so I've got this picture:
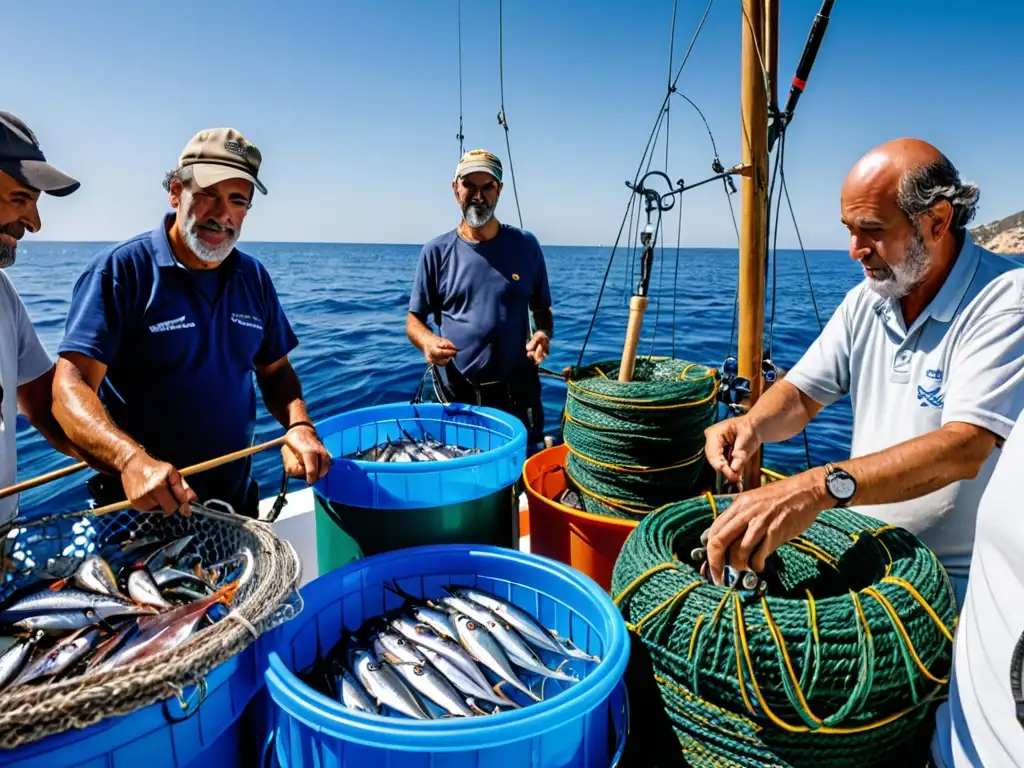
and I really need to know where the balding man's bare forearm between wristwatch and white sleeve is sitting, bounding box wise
[823,422,996,512]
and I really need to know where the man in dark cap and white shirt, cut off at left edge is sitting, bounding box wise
[0,112,92,524]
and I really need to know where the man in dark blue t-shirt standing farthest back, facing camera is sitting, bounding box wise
[406,150,554,444]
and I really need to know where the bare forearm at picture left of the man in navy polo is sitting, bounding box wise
[52,358,144,472]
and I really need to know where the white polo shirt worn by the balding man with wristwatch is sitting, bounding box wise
[785,234,1024,564]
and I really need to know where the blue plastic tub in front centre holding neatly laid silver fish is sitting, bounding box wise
[264,545,630,768]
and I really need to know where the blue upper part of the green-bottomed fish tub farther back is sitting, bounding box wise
[314,402,526,509]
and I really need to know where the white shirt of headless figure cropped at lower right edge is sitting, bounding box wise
[936,411,1024,768]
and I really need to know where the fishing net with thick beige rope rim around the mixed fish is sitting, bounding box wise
[0,504,301,749]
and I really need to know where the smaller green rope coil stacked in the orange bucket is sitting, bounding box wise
[562,357,718,519]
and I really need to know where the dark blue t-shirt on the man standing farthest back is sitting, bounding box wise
[409,224,551,384]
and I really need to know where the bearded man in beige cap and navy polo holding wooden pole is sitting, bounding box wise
[54,128,331,516]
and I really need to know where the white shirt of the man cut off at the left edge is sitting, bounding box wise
[0,269,53,524]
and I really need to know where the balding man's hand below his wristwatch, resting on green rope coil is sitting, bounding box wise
[708,467,833,585]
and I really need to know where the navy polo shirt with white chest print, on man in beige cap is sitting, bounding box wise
[58,214,298,504]
